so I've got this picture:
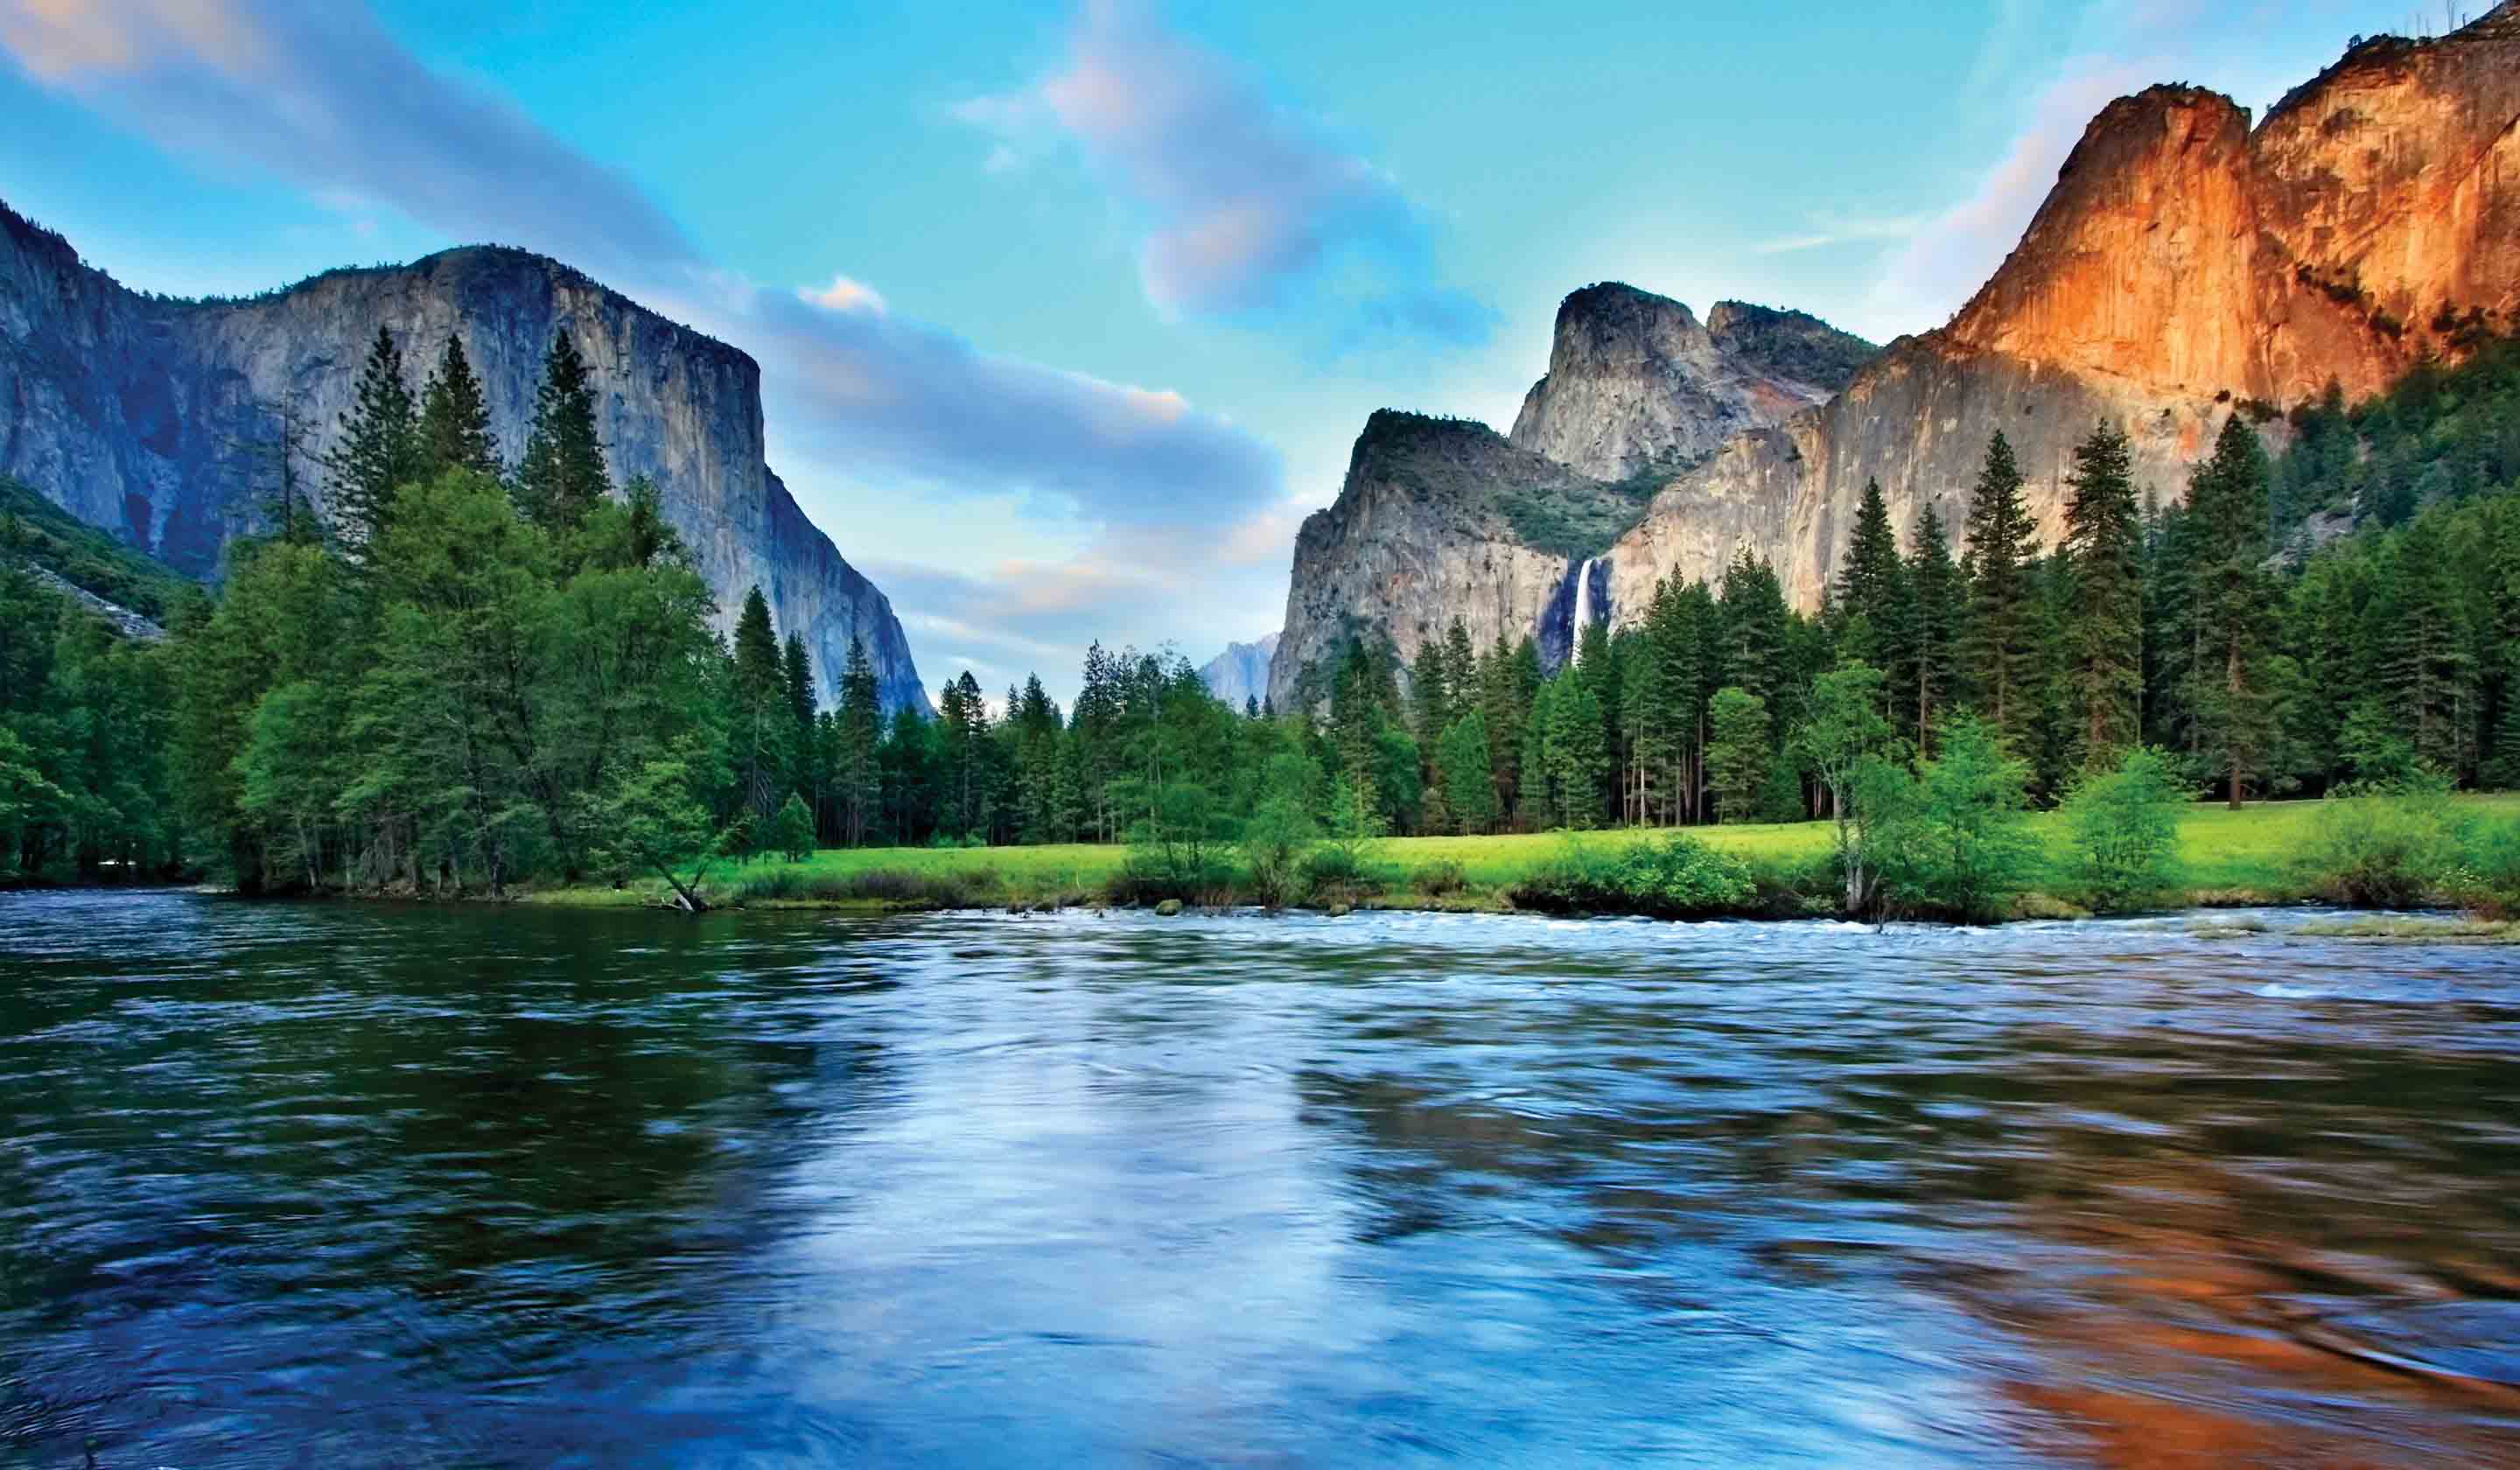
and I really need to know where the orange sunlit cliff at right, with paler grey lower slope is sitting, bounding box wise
[1610,3,2520,607]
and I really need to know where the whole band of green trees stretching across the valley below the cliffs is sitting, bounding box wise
[0,332,2520,890]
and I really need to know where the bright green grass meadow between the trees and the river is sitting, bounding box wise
[536,794,2520,907]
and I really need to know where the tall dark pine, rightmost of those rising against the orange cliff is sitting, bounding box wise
[2188,414,2276,809]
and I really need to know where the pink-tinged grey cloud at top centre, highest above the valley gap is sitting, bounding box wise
[956,0,1497,343]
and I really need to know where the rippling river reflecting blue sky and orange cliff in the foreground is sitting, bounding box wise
[0,892,2520,1470]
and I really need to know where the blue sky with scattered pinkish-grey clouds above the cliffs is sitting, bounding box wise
[0,0,2437,693]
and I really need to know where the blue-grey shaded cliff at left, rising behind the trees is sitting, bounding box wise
[0,206,928,709]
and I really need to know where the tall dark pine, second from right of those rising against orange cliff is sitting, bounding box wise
[2064,424,2145,772]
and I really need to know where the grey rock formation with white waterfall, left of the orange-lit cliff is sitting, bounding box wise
[1268,293,1875,709]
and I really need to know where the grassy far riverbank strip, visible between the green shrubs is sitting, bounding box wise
[529,794,2520,918]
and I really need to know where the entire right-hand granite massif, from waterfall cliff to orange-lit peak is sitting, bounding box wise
[1270,0,2520,706]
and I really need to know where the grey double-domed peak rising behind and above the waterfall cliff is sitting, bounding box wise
[1512,283,1875,480]
